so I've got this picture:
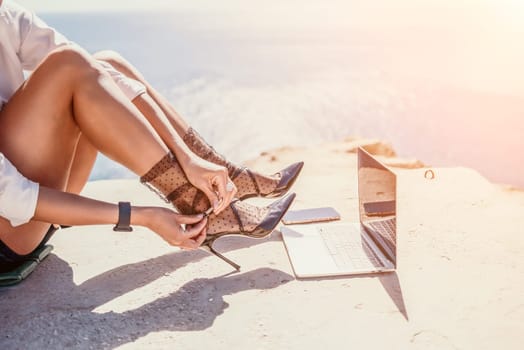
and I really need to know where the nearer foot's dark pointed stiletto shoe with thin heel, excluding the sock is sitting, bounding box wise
[201,193,295,271]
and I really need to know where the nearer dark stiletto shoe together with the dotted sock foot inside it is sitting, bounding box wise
[201,193,295,271]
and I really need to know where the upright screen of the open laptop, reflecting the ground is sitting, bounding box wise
[358,148,397,266]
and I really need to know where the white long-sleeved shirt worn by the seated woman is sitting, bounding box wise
[0,0,146,226]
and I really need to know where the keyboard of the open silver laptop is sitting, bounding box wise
[318,226,383,269]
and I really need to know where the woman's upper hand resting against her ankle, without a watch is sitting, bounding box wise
[183,155,237,214]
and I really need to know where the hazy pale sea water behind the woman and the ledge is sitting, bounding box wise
[41,7,524,187]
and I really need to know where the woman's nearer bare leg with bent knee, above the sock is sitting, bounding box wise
[0,48,167,254]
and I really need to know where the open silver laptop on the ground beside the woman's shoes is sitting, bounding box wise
[281,148,397,277]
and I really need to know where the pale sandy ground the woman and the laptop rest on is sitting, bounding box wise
[0,139,524,349]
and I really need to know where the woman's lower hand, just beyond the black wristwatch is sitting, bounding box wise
[136,207,207,249]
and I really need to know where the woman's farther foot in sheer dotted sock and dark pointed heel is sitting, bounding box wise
[183,128,304,199]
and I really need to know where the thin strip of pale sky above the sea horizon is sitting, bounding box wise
[14,0,524,17]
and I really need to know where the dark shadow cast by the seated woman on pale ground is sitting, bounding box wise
[0,237,293,349]
